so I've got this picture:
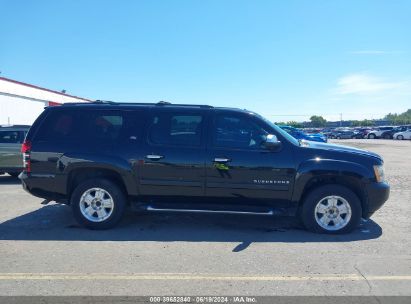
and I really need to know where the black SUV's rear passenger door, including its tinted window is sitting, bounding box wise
[138,108,207,202]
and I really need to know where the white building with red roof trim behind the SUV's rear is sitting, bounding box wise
[0,77,91,125]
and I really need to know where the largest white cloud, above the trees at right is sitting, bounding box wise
[335,73,407,95]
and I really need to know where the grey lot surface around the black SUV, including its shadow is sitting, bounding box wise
[0,140,411,295]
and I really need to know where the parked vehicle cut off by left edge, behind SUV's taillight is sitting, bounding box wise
[0,125,30,177]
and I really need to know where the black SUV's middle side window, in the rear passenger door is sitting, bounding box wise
[148,113,203,146]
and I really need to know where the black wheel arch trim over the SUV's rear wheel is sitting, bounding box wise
[67,168,127,201]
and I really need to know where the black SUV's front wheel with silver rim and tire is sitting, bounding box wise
[301,185,362,234]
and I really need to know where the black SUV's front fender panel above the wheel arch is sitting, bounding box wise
[292,159,373,202]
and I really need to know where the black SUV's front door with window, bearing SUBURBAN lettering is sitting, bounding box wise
[206,111,295,209]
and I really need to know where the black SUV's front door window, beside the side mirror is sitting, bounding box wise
[213,116,268,149]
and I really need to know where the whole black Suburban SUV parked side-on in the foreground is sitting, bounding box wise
[20,102,389,233]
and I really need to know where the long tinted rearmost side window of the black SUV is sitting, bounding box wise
[36,110,143,142]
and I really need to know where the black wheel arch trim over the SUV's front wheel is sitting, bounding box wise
[299,176,367,215]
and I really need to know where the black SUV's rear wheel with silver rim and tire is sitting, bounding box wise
[70,179,126,230]
